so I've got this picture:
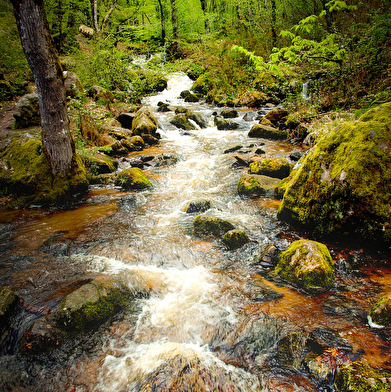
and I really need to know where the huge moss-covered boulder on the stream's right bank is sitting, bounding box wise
[278,103,391,243]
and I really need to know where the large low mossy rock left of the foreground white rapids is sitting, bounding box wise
[48,278,134,334]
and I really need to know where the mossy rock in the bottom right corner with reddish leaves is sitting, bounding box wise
[334,362,391,392]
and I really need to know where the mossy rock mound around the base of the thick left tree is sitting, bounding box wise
[0,134,88,206]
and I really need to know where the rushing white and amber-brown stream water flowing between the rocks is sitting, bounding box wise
[0,75,391,391]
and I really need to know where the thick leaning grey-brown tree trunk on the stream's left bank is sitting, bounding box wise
[11,0,74,176]
